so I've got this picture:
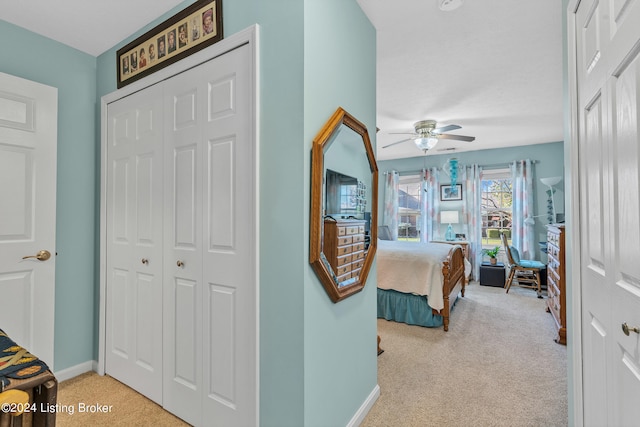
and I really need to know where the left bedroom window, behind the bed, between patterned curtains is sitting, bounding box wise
[398,175,422,242]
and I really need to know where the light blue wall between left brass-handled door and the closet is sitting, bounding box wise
[0,20,98,370]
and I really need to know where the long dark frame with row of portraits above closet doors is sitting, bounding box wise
[116,0,223,89]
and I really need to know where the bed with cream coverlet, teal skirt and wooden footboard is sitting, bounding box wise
[377,240,471,331]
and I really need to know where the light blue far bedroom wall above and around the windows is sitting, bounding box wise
[378,142,564,261]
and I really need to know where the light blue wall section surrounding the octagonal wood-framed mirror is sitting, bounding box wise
[297,0,377,427]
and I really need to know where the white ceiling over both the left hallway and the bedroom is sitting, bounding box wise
[0,0,563,160]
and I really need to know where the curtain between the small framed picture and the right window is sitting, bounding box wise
[461,165,482,280]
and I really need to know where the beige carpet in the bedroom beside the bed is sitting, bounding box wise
[362,283,567,427]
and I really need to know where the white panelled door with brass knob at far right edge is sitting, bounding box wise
[575,0,640,426]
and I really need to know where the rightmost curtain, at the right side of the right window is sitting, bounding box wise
[511,160,536,259]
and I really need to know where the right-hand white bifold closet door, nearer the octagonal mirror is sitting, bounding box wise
[164,46,257,426]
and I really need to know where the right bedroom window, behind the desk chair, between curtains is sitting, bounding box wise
[481,169,513,248]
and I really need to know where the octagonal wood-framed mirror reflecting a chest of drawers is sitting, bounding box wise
[309,108,378,302]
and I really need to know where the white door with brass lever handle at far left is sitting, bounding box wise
[0,73,58,369]
